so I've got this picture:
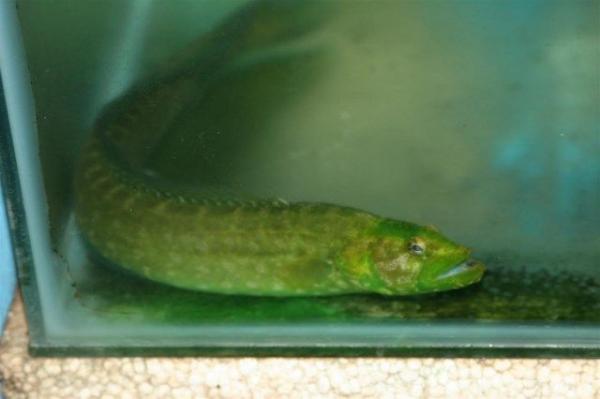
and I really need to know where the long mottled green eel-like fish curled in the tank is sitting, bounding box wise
[75,1,485,296]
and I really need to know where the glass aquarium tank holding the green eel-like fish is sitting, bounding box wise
[0,0,600,356]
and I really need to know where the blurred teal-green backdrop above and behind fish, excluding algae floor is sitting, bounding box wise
[15,1,600,253]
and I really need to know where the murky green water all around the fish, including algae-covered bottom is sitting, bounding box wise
[8,0,600,356]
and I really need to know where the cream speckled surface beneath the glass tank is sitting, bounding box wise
[0,298,600,399]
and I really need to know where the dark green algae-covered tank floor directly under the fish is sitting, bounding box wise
[76,254,600,325]
